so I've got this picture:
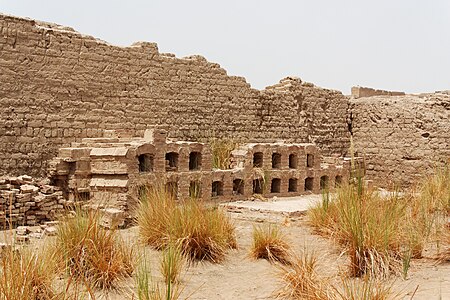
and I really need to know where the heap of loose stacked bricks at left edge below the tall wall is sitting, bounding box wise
[0,175,66,227]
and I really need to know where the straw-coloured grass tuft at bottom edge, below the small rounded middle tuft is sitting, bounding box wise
[277,251,335,300]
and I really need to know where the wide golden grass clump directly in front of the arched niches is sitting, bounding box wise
[137,187,237,262]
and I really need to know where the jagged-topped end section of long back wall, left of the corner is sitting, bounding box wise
[257,77,350,156]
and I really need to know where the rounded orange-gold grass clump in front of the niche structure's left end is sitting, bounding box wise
[55,210,134,289]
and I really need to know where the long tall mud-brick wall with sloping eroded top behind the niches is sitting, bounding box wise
[0,15,348,175]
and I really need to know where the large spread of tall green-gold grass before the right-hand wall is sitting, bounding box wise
[308,163,450,277]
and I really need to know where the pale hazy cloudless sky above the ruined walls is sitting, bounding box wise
[0,0,450,94]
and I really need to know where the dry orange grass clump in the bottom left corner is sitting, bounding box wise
[0,247,61,300]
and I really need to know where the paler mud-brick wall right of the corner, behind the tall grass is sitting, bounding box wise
[350,92,450,186]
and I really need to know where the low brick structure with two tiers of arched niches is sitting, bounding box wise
[49,129,349,212]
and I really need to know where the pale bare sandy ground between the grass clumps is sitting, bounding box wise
[1,196,450,300]
